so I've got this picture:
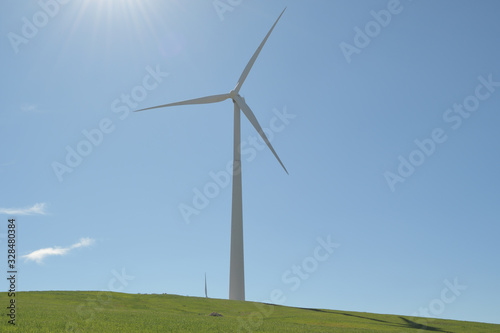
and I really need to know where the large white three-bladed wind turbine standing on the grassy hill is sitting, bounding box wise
[136,7,288,301]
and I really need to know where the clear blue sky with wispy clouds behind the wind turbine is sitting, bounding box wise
[0,0,500,323]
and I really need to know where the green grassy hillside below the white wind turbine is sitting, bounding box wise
[0,291,500,333]
